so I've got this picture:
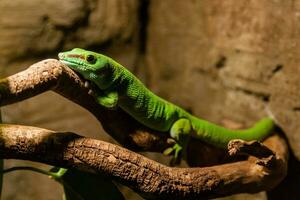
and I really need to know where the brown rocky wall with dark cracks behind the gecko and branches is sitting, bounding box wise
[0,0,300,200]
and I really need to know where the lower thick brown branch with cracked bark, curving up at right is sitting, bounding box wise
[0,125,287,199]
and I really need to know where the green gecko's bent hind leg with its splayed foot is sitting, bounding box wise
[164,118,192,163]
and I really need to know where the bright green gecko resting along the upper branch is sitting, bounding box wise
[58,48,275,159]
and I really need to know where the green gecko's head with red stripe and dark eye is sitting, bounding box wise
[58,48,107,81]
